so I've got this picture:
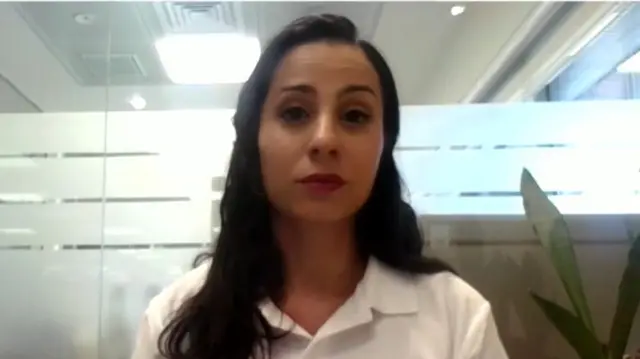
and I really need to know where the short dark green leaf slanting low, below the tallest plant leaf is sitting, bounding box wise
[531,292,606,359]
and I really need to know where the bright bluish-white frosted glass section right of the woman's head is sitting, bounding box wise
[396,101,640,215]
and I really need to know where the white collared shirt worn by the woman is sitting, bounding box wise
[132,259,507,359]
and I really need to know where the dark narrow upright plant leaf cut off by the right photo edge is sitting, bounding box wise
[609,236,640,359]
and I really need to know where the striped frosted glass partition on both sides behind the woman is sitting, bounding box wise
[0,102,640,359]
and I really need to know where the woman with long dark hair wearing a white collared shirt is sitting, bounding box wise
[133,15,506,359]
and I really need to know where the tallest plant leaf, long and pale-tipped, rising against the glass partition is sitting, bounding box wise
[520,169,595,332]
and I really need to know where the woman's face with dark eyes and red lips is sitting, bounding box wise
[259,43,384,221]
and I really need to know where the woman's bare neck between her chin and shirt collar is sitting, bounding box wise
[273,218,364,299]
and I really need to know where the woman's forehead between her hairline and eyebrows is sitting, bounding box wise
[273,42,380,91]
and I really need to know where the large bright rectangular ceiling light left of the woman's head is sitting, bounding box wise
[155,33,260,85]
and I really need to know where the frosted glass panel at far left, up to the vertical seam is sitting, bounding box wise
[0,113,105,359]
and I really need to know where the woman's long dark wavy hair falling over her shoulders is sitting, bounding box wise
[158,15,450,359]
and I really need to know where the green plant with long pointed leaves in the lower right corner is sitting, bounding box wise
[520,169,640,359]
